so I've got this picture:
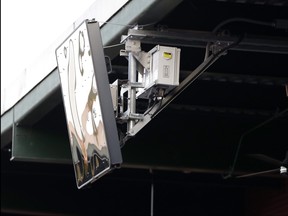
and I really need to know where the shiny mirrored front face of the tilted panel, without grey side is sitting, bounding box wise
[56,22,110,188]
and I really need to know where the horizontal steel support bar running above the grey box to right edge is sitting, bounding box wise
[126,29,288,54]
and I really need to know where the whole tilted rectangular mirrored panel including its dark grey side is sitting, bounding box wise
[56,20,122,188]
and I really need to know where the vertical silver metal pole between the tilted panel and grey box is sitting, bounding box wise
[127,52,137,133]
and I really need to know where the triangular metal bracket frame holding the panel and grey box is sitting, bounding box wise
[121,28,248,143]
